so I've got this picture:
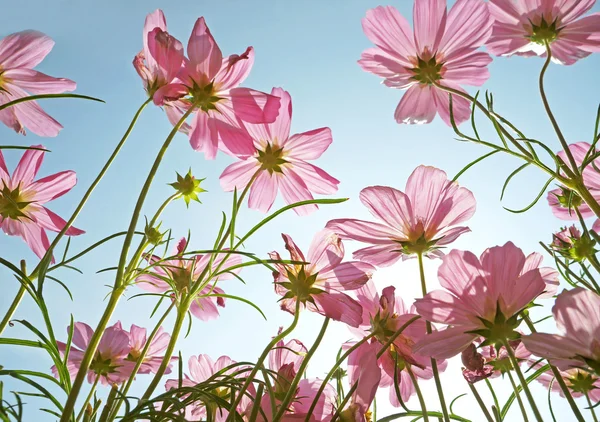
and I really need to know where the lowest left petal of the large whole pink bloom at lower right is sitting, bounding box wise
[413,327,477,359]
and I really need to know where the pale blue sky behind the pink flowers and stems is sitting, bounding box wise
[0,0,600,421]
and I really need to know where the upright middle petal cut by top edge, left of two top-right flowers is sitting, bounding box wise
[413,0,446,53]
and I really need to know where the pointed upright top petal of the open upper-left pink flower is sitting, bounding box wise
[187,17,223,84]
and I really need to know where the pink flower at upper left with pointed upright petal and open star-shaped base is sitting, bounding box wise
[153,18,279,160]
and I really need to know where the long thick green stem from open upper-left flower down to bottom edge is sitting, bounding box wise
[60,106,195,422]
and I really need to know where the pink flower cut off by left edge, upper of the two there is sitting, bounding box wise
[0,31,76,136]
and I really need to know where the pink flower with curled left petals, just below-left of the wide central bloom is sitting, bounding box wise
[269,229,375,327]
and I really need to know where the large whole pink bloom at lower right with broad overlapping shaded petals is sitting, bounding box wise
[414,242,546,359]
